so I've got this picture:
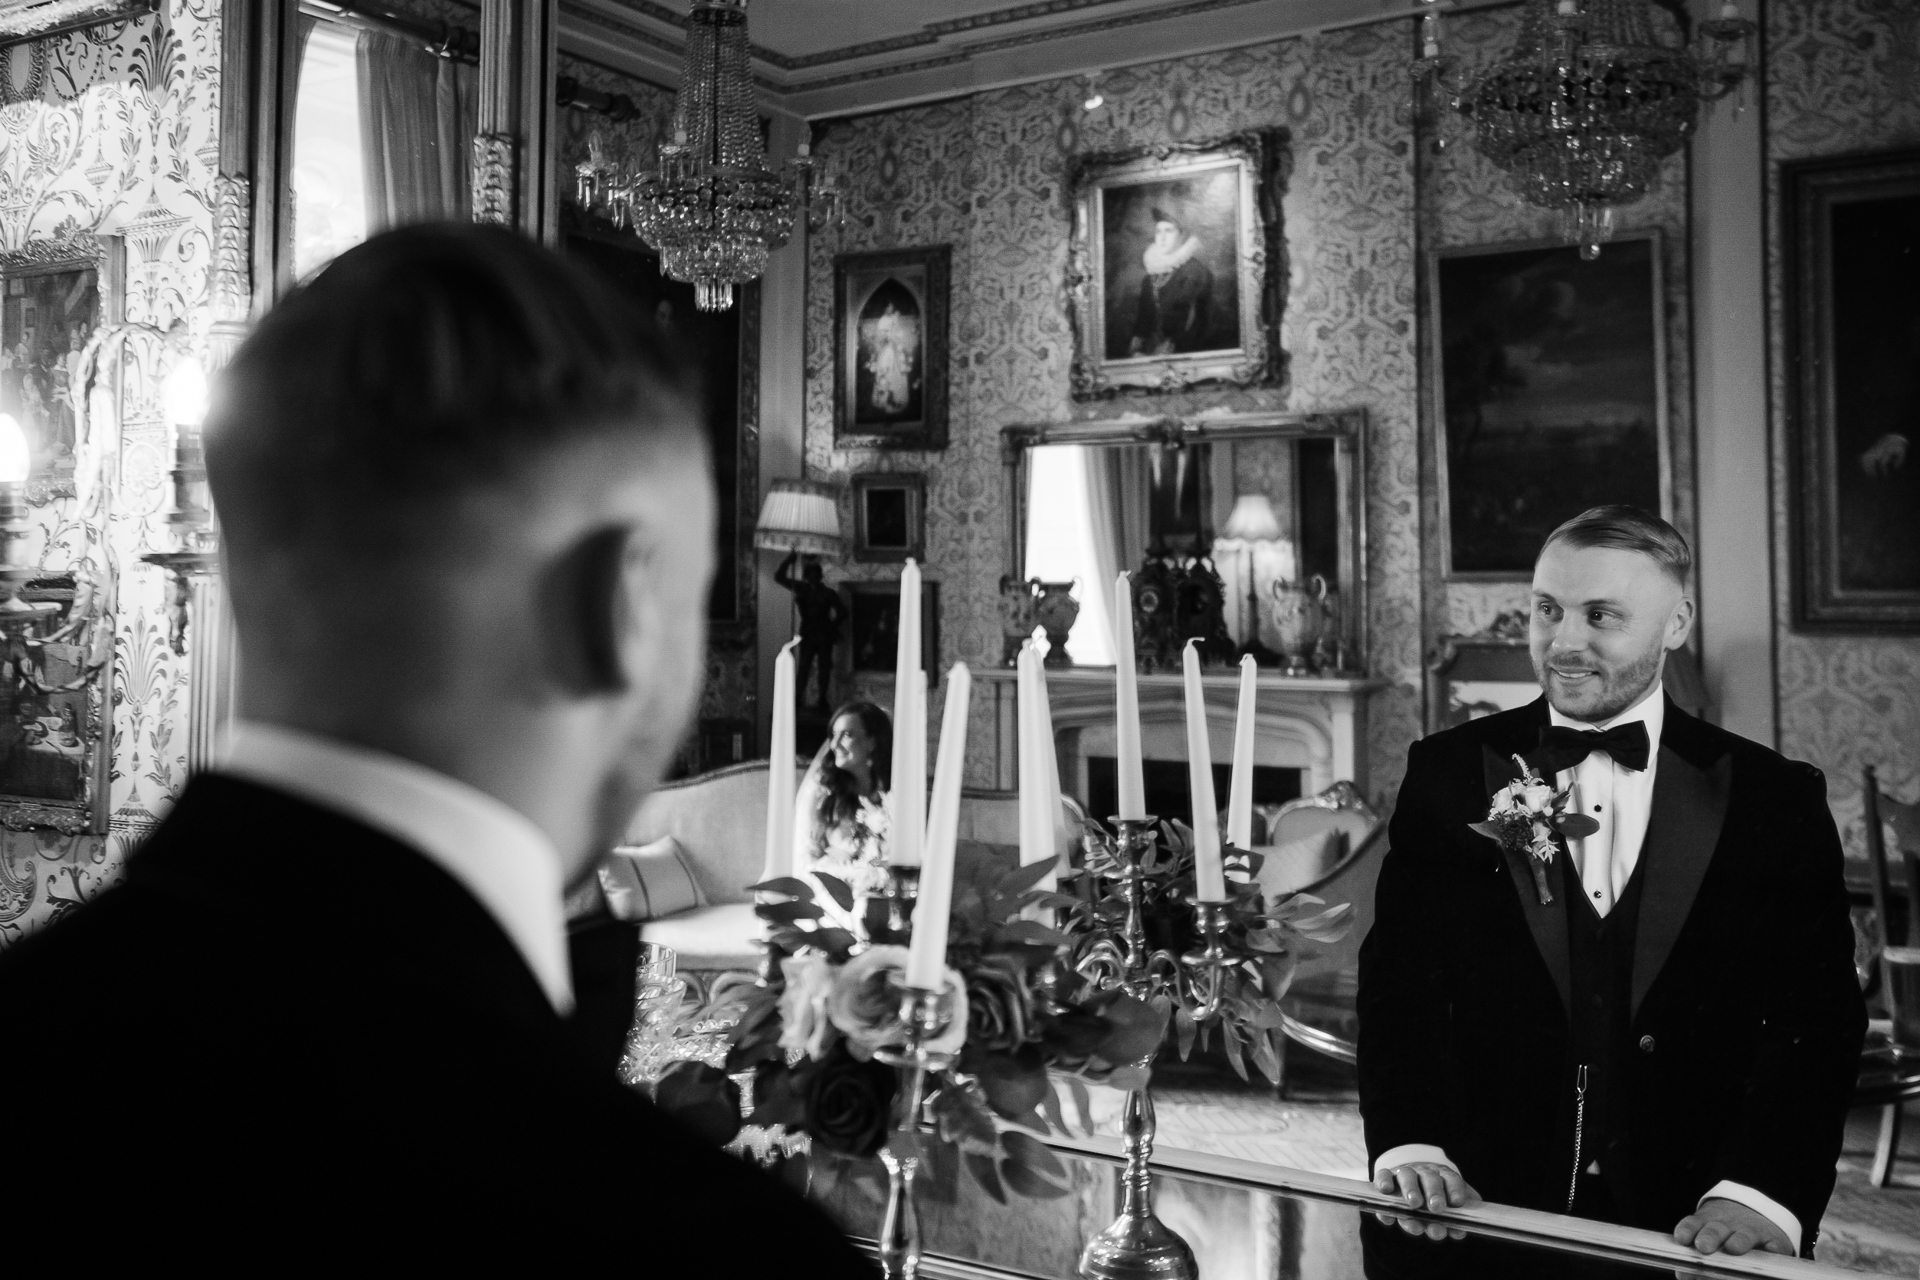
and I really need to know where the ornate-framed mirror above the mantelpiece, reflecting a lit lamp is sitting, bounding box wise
[1002,409,1367,676]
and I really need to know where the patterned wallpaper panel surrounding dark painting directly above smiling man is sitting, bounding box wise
[1419,8,1697,647]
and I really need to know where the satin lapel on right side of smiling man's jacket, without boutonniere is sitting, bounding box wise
[1632,721,1734,1015]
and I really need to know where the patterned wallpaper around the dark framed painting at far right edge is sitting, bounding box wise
[1766,0,1920,856]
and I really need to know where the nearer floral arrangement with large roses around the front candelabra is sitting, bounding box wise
[708,865,1165,1199]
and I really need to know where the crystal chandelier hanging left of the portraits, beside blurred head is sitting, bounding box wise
[574,0,837,311]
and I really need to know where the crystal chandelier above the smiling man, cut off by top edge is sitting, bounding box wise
[1413,0,1757,259]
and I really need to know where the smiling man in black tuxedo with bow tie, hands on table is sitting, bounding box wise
[1359,507,1866,1274]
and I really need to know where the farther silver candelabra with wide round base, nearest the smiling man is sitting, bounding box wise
[1077,818,1227,1280]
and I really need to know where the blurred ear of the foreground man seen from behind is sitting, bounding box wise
[541,526,637,697]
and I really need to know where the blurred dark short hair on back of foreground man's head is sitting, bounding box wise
[205,223,699,568]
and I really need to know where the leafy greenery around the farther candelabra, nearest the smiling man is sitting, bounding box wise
[1066,821,1354,1084]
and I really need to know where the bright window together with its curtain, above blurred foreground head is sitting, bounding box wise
[294,13,478,278]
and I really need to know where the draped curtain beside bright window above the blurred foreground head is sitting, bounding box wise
[357,31,478,232]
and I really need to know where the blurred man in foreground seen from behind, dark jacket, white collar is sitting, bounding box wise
[0,225,870,1276]
